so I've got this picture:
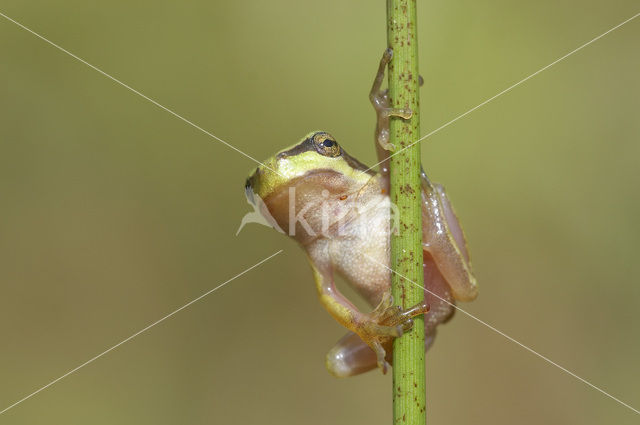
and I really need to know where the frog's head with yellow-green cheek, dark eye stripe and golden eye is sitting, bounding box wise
[245,131,375,239]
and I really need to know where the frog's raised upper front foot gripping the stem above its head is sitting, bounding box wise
[369,48,413,151]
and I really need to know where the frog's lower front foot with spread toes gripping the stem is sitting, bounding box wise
[356,292,429,373]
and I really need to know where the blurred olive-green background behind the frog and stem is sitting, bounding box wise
[0,0,640,425]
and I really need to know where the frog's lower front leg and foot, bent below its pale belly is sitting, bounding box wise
[311,256,429,373]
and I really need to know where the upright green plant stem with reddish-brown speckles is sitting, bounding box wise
[387,0,426,425]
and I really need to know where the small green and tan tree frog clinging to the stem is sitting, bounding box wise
[245,49,477,377]
